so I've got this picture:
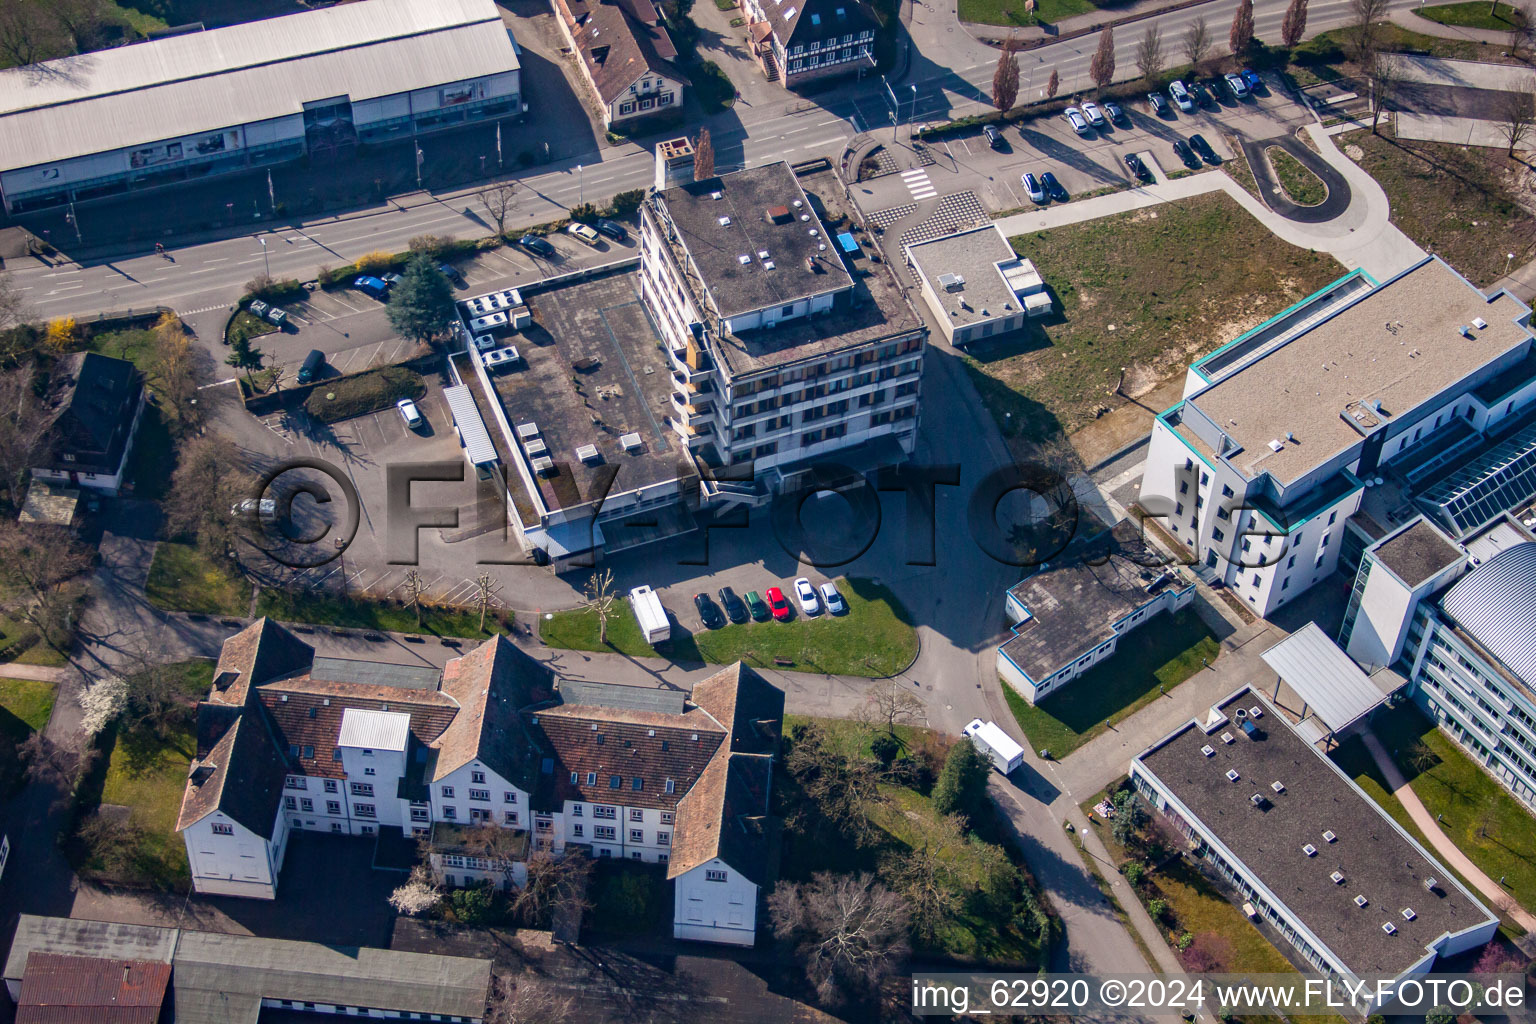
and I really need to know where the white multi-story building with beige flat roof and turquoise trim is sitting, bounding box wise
[1141,256,1536,614]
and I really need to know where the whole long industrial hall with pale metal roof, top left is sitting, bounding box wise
[0,0,522,213]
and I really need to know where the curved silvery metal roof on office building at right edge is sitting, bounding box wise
[1441,540,1536,686]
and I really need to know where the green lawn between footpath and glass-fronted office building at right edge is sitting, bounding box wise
[1372,703,1536,907]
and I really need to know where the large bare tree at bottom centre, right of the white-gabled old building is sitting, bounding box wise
[768,872,908,1003]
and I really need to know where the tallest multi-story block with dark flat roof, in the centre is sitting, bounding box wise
[641,160,928,500]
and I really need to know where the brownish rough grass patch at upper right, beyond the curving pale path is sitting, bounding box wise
[1341,130,1536,287]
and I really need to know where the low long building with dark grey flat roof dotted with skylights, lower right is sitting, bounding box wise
[1130,688,1499,1015]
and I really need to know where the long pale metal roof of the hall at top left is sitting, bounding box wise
[0,0,518,170]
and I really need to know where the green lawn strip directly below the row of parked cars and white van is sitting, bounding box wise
[539,579,917,679]
